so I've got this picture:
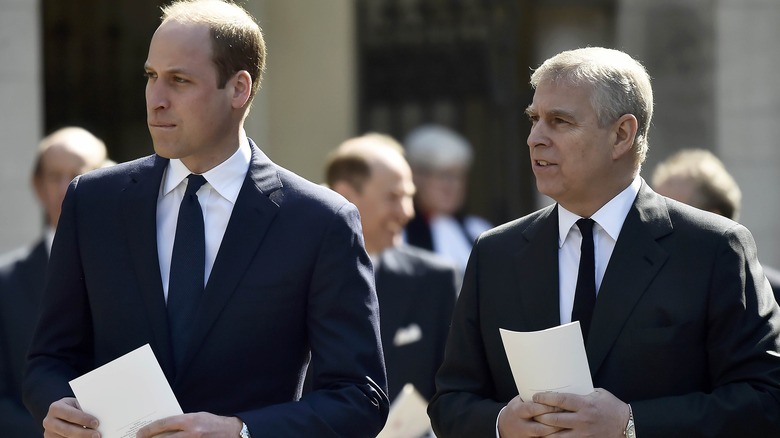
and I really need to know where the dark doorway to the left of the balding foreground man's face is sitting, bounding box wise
[41,0,163,162]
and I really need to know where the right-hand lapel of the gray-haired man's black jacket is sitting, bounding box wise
[586,182,672,376]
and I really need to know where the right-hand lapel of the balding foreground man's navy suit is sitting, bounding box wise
[178,140,282,376]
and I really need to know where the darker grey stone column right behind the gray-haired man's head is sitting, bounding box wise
[615,0,716,180]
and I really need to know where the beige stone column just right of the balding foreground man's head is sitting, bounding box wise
[246,0,357,182]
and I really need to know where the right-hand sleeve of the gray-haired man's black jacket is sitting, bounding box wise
[628,225,780,438]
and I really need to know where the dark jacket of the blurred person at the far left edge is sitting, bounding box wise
[0,240,49,438]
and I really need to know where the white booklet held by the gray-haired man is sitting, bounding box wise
[499,321,593,401]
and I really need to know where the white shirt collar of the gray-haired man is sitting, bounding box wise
[558,175,642,248]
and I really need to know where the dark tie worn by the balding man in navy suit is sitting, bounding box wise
[168,174,206,369]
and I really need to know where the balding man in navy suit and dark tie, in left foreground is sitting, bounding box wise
[24,1,388,438]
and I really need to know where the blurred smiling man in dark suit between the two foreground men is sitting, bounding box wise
[325,134,457,400]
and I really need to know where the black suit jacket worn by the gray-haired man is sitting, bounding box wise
[429,182,780,438]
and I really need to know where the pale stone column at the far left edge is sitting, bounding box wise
[0,0,43,252]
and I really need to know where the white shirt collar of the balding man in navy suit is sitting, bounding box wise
[163,132,252,204]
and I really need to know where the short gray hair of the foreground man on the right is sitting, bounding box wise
[531,47,653,169]
